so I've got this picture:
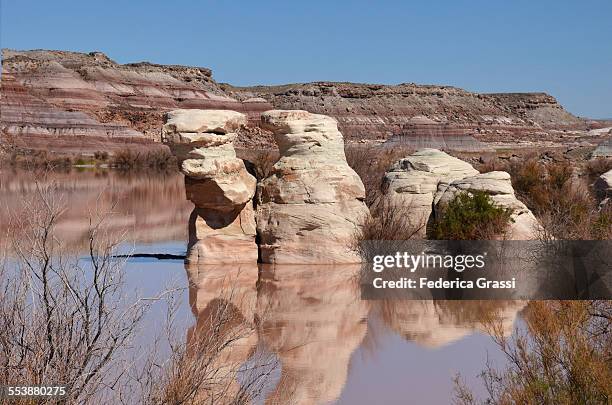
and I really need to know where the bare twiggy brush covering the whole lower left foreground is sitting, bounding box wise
[0,178,275,404]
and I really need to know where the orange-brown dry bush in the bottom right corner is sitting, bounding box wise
[454,301,612,405]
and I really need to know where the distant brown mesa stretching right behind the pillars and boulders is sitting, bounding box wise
[230,82,585,142]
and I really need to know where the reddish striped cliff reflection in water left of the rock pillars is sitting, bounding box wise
[0,170,191,251]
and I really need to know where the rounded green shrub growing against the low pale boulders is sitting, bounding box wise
[432,191,512,240]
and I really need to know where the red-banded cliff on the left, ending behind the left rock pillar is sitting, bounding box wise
[0,49,272,153]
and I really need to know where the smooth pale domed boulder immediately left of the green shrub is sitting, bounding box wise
[383,149,478,235]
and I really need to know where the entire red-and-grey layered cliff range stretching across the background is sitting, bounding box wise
[0,50,586,152]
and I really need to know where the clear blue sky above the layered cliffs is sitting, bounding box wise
[0,0,612,118]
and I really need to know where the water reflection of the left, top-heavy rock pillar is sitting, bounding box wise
[184,263,258,403]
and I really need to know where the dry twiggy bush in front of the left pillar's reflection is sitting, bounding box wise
[134,290,279,404]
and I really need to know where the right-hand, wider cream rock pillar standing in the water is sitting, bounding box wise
[257,110,368,264]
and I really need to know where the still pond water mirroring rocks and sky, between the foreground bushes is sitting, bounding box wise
[0,171,524,404]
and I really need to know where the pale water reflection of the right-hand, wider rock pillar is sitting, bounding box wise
[257,265,368,404]
